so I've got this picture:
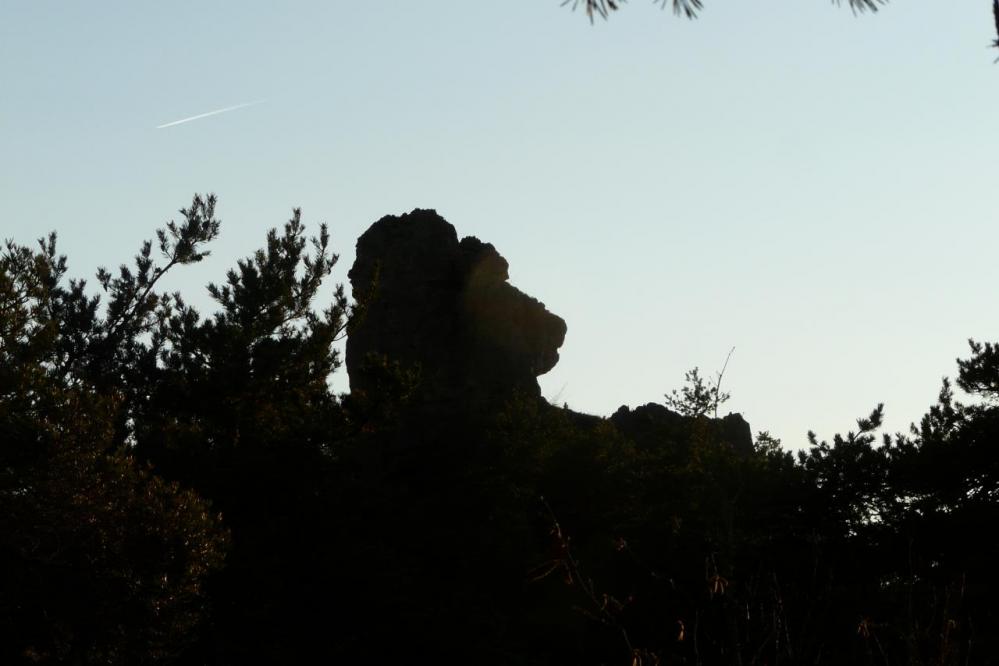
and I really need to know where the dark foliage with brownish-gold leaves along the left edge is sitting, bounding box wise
[0,226,227,663]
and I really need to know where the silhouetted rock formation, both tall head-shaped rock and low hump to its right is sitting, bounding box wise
[346,209,753,452]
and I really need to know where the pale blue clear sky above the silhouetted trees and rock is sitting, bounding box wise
[0,0,999,449]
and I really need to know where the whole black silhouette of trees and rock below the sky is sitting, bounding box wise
[0,197,999,666]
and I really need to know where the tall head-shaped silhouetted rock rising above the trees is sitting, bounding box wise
[346,209,566,399]
